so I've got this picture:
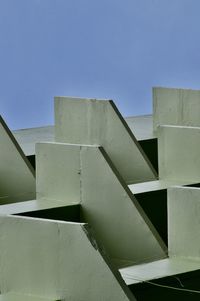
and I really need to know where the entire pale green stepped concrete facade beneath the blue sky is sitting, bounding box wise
[0,88,200,301]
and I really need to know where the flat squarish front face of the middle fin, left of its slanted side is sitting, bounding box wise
[36,143,81,204]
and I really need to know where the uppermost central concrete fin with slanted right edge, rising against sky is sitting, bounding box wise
[55,97,157,184]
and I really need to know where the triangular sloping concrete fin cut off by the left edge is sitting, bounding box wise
[0,117,35,204]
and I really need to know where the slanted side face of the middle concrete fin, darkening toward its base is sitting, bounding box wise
[81,148,166,266]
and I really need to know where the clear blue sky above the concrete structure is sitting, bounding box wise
[0,0,200,129]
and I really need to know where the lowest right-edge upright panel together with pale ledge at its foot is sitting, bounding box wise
[120,187,200,285]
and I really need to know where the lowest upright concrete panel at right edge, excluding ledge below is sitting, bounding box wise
[168,187,200,260]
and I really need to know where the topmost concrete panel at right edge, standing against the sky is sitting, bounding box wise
[153,87,200,131]
